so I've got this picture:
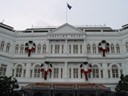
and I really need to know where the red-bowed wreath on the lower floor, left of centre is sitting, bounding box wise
[40,61,52,80]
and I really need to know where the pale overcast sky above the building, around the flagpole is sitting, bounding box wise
[0,0,128,30]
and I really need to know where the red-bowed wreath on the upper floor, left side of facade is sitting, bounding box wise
[25,41,36,57]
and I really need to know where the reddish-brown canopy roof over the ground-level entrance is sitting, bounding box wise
[24,83,109,90]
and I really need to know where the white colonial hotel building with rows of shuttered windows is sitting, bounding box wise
[0,23,128,91]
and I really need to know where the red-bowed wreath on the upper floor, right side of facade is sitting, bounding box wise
[99,40,109,57]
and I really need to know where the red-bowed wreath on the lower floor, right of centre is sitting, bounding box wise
[80,62,92,81]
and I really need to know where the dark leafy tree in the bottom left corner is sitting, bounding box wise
[0,76,19,96]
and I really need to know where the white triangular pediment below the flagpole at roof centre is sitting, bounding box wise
[52,23,83,34]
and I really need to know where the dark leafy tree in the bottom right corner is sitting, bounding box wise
[115,74,128,96]
